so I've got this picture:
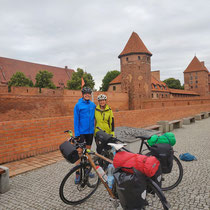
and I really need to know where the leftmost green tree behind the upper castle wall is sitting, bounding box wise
[8,72,33,89]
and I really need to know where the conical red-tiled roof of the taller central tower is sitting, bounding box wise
[118,32,152,58]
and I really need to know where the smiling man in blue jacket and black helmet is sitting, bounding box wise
[74,87,96,184]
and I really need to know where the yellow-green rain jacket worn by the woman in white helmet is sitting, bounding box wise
[95,104,114,136]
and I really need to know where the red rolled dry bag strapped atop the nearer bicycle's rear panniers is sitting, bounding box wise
[113,151,160,177]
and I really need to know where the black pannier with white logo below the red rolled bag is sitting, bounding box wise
[113,168,147,210]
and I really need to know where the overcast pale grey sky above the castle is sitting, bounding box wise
[0,0,210,88]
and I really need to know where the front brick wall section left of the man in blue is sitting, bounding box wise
[0,116,73,163]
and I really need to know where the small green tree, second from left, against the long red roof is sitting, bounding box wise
[35,70,56,89]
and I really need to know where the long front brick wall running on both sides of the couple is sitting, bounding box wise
[0,103,210,164]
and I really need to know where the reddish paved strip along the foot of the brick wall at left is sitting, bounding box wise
[2,150,64,177]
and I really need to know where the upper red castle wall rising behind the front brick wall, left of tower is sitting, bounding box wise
[0,87,128,122]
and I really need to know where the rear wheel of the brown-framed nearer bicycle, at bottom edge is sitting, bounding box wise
[143,179,170,210]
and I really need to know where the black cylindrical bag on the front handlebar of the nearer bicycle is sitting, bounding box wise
[59,141,79,163]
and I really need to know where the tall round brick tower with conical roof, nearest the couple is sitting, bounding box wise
[118,32,152,109]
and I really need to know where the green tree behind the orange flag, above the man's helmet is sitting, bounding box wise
[67,68,95,90]
